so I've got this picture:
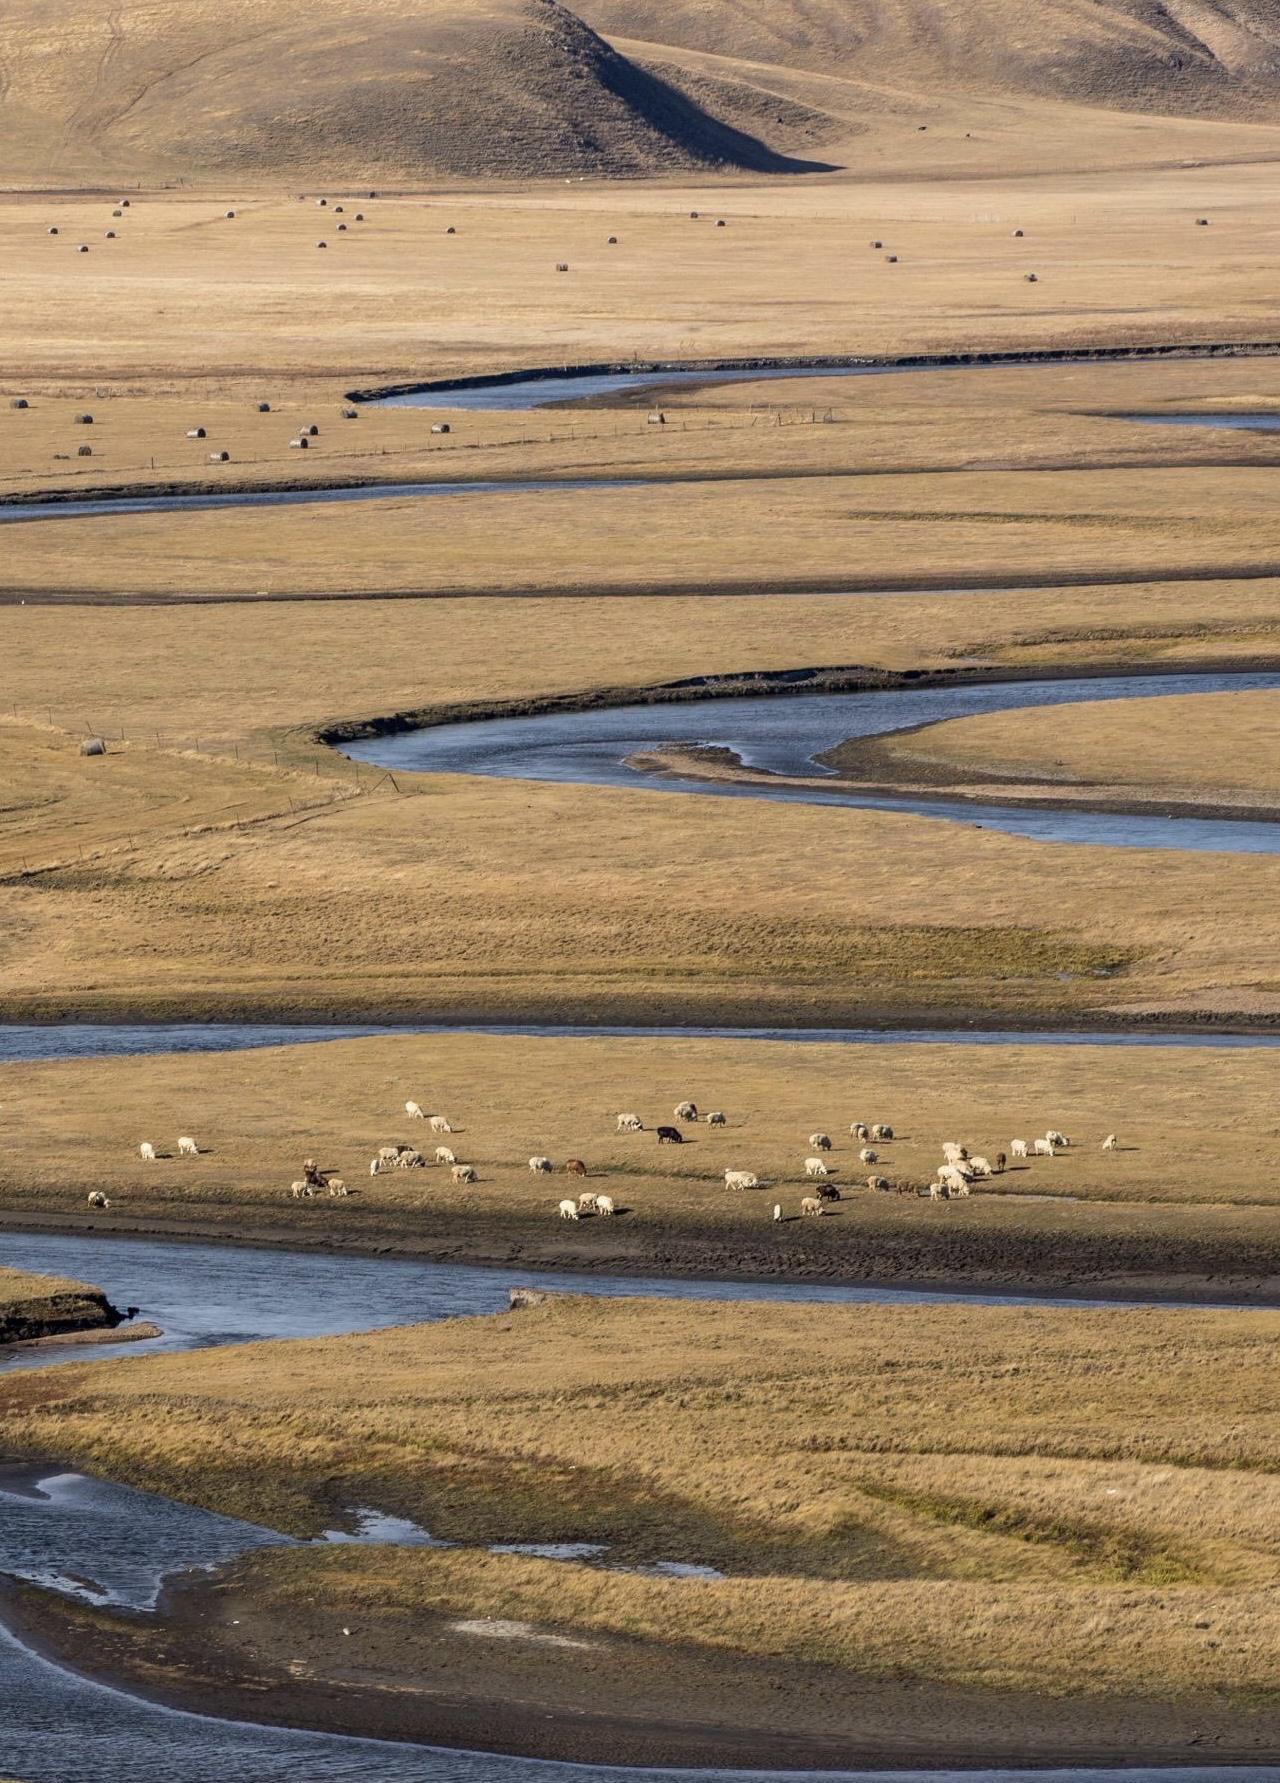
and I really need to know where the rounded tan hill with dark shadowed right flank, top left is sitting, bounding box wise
[0,0,823,184]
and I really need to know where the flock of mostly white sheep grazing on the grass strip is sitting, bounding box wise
[89,1100,1120,1220]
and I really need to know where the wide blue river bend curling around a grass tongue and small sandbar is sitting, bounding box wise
[344,672,1280,854]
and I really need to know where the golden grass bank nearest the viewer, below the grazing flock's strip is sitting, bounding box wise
[10,1298,1280,1717]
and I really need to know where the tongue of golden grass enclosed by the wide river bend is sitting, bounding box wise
[888,692,1280,808]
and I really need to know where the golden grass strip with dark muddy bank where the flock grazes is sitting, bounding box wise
[0,1032,1280,1294]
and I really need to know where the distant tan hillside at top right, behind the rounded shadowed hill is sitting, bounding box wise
[581,0,1280,118]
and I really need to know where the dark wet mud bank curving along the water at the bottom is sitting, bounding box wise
[0,1567,1280,1769]
